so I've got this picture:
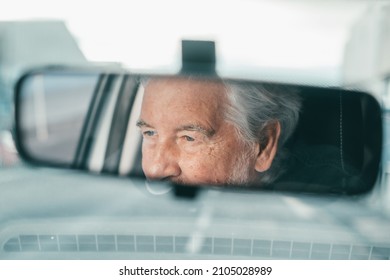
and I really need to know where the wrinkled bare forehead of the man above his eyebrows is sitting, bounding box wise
[140,78,227,130]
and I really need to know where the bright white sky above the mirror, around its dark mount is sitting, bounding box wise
[0,0,370,83]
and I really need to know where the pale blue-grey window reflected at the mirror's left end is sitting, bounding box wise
[18,73,98,165]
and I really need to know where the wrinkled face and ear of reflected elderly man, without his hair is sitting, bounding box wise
[138,78,279,184]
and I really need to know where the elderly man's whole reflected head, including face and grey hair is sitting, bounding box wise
[137,77,300,185]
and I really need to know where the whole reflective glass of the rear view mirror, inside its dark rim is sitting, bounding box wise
[16,71,382,194]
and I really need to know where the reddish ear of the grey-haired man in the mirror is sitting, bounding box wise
[255,121,280,172]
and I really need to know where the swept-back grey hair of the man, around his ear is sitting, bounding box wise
[224,81,301,183]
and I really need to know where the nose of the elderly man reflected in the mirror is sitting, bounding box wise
[142,139,181,180]
